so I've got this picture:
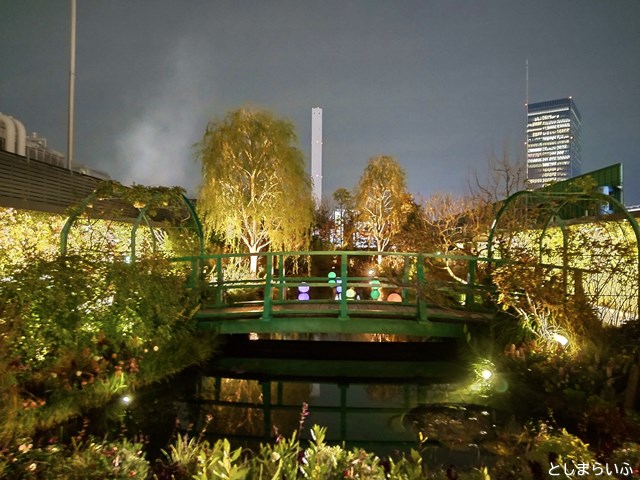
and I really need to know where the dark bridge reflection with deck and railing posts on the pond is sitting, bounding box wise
[191,337,476,453]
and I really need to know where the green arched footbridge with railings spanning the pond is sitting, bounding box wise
[174,251,510,337]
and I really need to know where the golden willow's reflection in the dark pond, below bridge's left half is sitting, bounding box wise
[199,377,311,437]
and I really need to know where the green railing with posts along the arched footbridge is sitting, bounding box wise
[174,251,496,322]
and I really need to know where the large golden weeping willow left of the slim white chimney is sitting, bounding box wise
[198,108,313,274]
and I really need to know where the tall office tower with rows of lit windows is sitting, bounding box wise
[527,97,582,189]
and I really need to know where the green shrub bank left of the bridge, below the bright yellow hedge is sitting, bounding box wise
[0,253,213,442]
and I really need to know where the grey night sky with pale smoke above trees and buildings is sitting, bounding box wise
[0,0,640,205]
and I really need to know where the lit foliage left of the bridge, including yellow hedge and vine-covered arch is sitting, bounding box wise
[0,182,214,446]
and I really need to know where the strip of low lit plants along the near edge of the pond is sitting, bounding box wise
[5,418,640,480]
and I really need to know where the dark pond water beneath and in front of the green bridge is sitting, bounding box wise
[140,336,495,465]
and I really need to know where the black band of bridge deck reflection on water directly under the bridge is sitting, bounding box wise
[211,335,466,383]
